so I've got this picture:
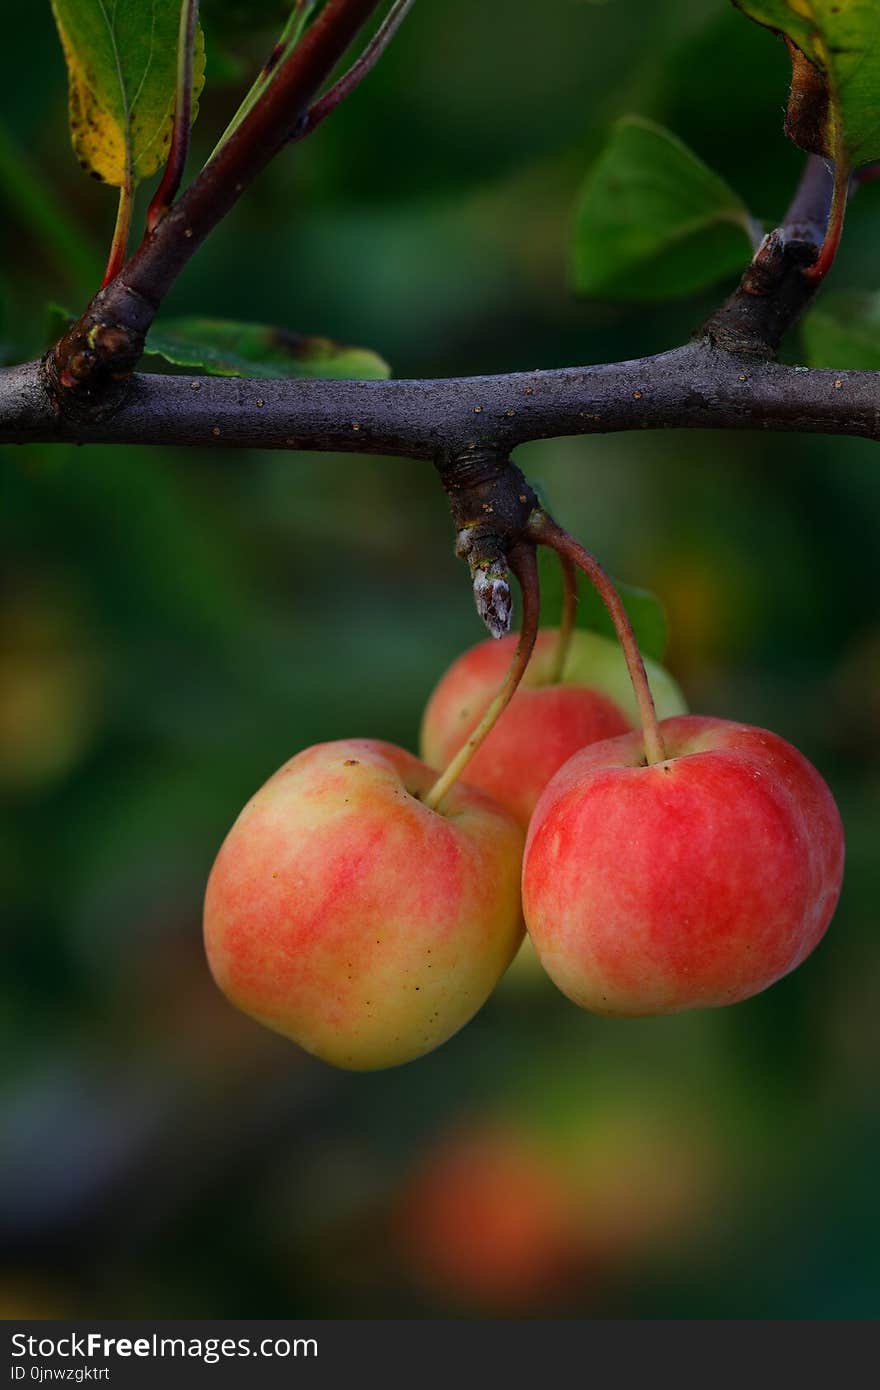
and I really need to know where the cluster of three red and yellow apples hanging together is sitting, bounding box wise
[204,630,844,1070]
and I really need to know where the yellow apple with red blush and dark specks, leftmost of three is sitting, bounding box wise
[204,739,524,1070]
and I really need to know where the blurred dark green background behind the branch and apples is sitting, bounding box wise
[0,0,880,1318]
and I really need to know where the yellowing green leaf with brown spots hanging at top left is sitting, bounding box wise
[51,0,204,188]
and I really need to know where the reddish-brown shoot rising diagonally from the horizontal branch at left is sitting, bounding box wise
[47,0,381,406]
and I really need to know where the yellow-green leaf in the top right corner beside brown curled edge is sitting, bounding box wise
[733,0,880,168]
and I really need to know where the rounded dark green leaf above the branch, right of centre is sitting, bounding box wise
[573,117,753,300]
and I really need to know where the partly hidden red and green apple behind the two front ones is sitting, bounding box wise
[421,628,687,827]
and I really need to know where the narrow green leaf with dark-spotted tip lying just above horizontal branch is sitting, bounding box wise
[146,318,391,381]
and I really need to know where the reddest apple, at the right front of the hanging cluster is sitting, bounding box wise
[523,716,844,1016]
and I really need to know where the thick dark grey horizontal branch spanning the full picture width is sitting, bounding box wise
[0,341,880,459]
